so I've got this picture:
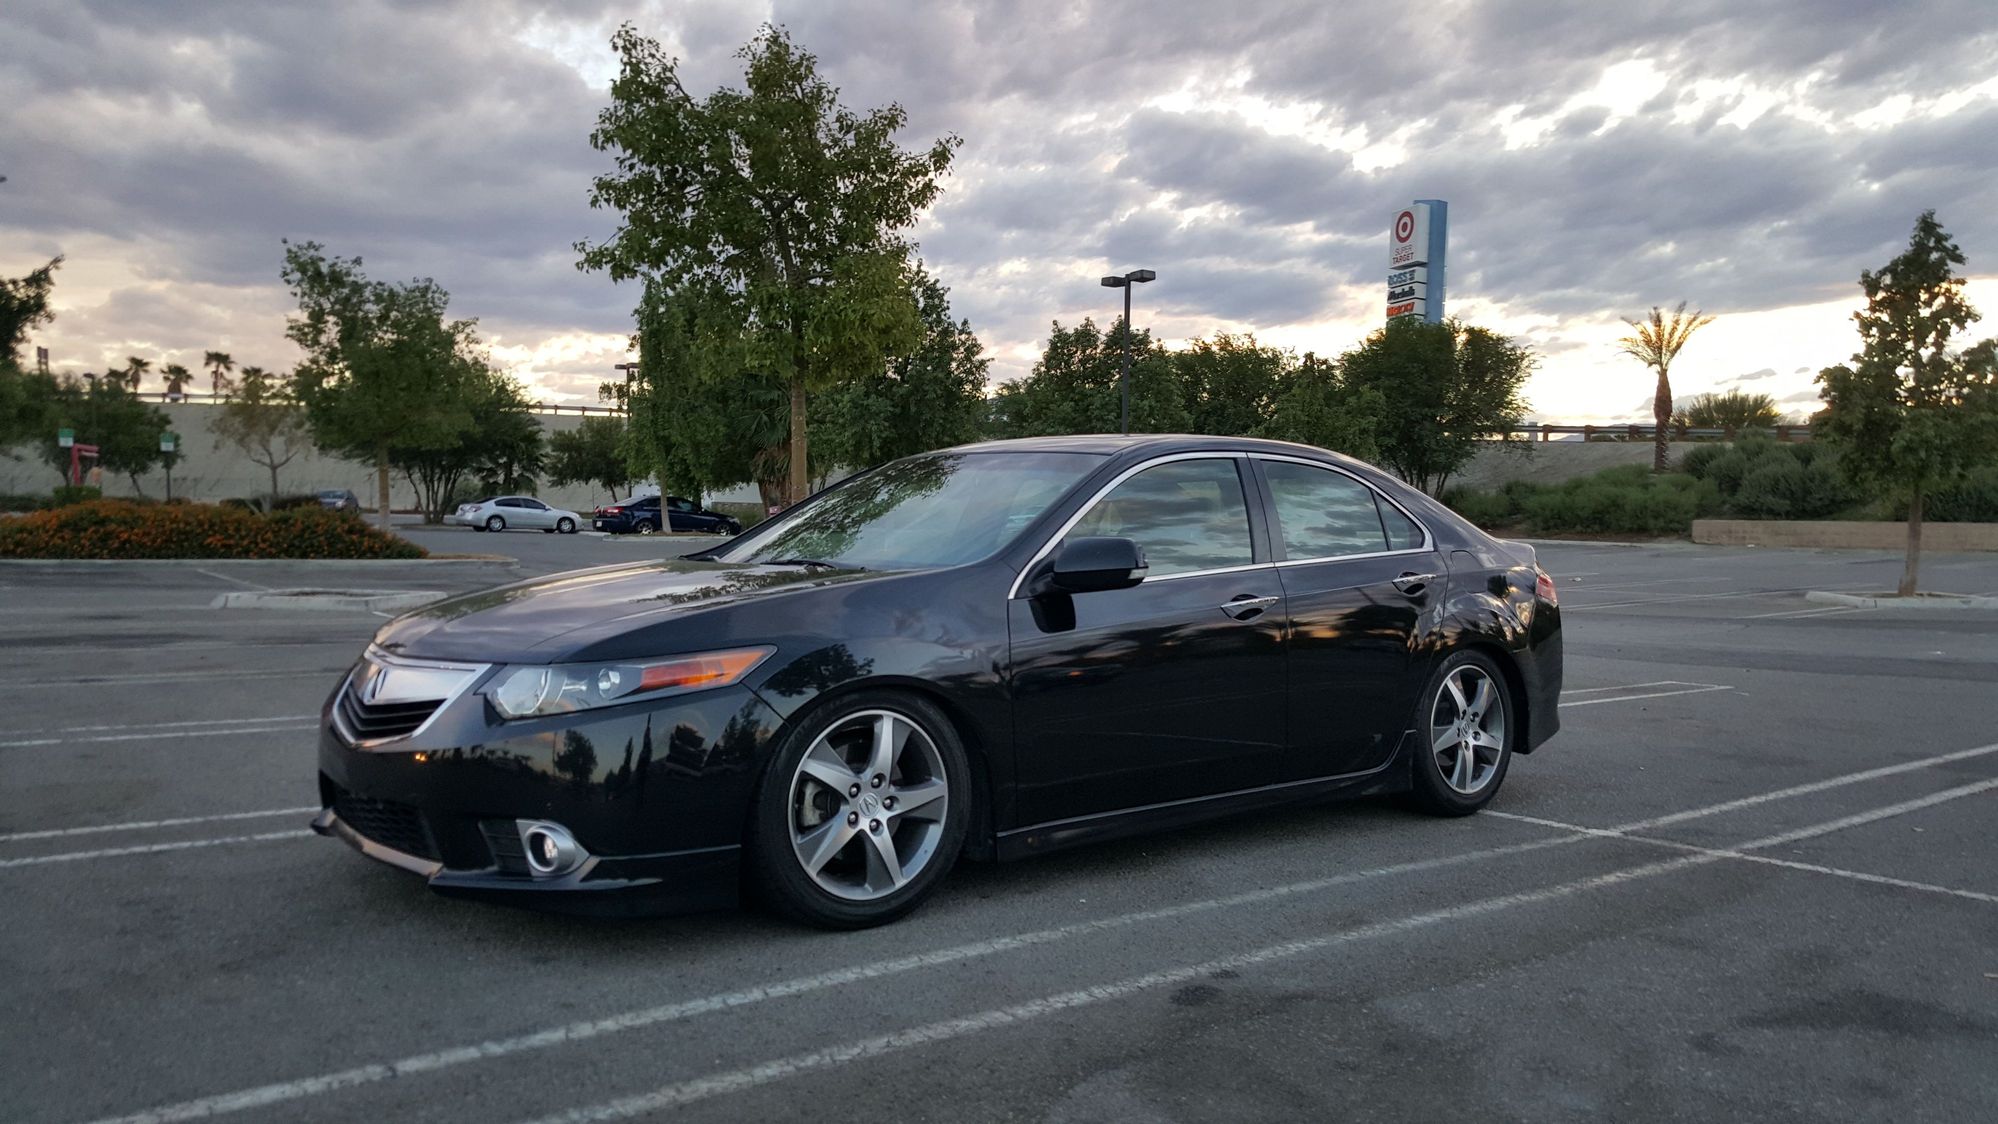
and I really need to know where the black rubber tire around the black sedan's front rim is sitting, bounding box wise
[743,691,977,928]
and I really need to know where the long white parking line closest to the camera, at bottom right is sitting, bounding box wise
[515,779,1998,1124]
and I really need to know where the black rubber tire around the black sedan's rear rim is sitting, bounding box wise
[1409,651,1520,817]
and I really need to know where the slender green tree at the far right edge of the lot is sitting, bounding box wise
[1818,212,1998,597]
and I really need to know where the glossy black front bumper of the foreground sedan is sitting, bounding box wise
[312,685,779,914]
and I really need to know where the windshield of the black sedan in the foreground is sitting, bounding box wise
[713,453,1103,569]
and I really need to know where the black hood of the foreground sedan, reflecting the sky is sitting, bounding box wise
[376,559,889,663]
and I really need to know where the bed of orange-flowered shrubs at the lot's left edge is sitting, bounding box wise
[0,499,426,559]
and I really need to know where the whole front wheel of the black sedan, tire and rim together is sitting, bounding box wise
[749,691,971,928]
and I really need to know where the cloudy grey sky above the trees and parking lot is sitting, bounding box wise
[0,0,1998,421]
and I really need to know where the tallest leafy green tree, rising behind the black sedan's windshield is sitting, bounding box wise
[577,24,959,503]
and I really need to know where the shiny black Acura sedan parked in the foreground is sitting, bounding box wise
[314,437,1560,926]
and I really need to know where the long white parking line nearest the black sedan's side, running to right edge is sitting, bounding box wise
[77,745,1998,1124]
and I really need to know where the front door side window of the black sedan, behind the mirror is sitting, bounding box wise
[1069,459,1255,577]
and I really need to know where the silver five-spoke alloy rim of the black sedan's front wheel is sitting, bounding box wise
[787,711,949,902]
